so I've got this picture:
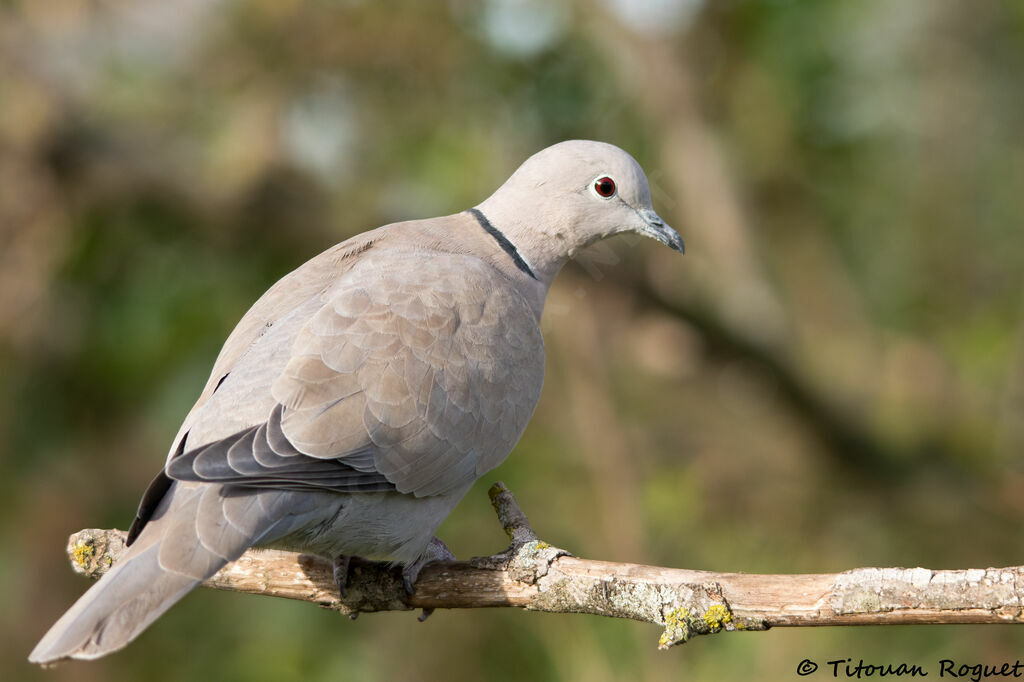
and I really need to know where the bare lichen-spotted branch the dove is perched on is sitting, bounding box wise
[61,482,1024,648]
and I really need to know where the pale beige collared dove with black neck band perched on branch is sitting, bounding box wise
[29,140,683,664]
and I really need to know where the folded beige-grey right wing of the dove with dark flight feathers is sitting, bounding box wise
[167,250,544,496]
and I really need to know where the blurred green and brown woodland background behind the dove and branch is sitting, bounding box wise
[6,0,1024,681]
